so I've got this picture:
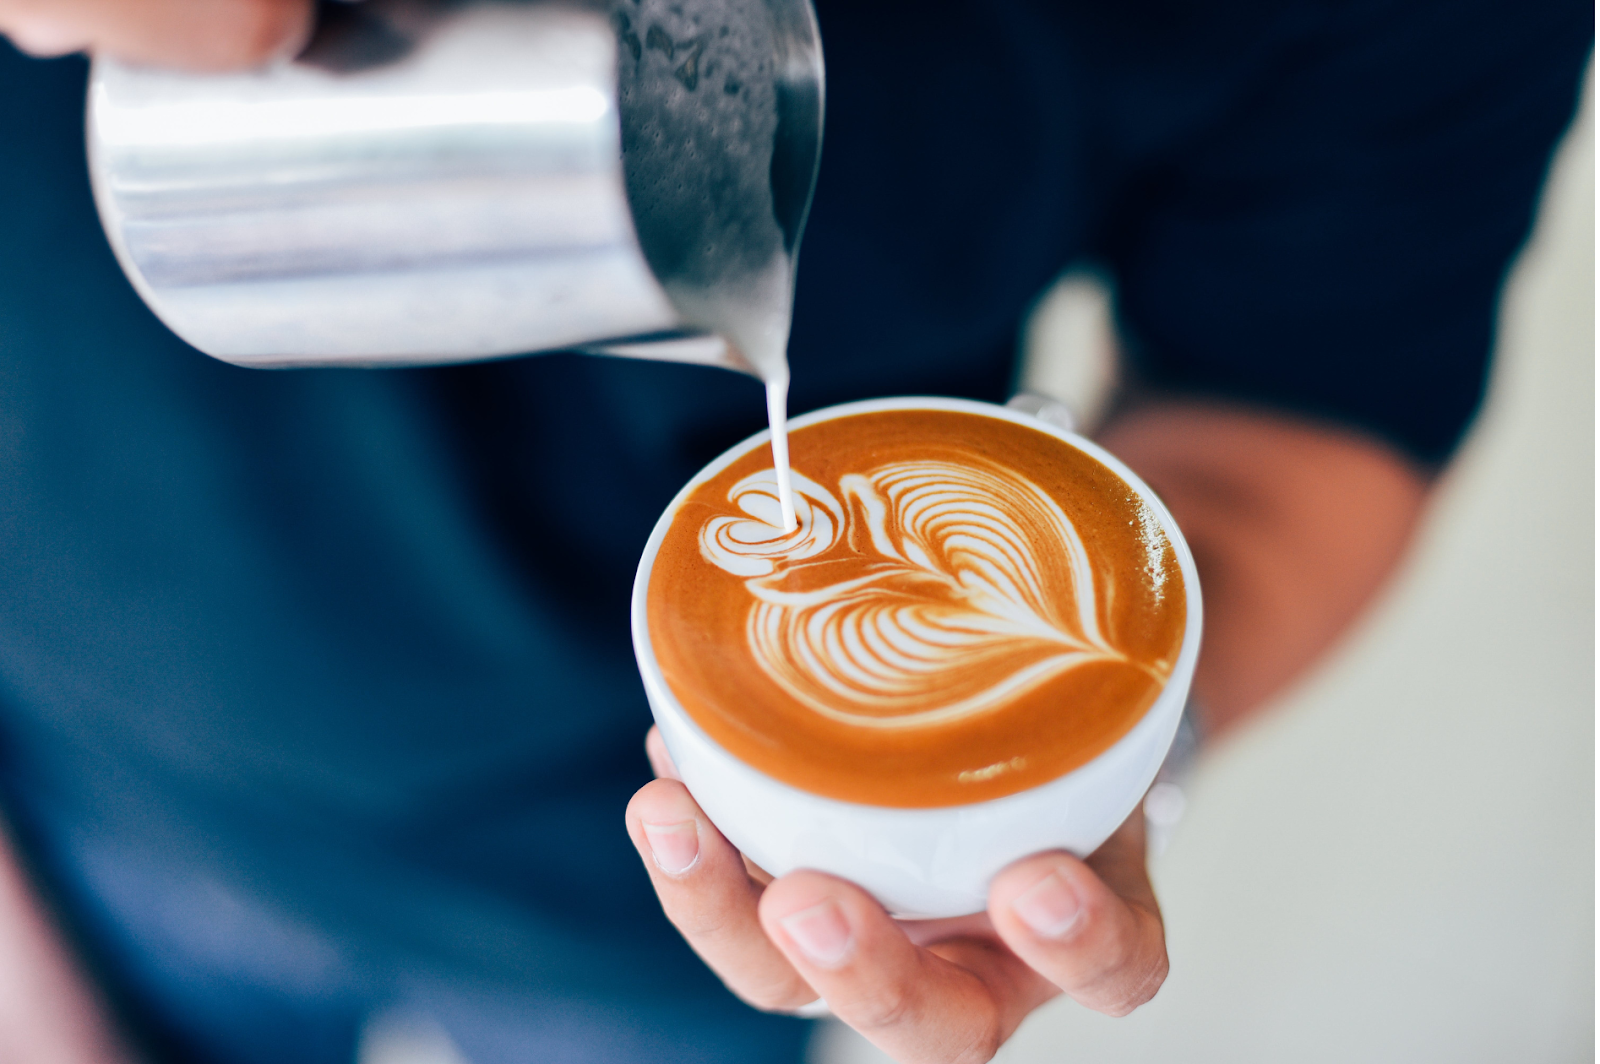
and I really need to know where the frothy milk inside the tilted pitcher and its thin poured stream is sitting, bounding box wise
[613,0,814,530]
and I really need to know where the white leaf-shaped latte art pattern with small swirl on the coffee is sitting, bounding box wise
[701,458,1170,728]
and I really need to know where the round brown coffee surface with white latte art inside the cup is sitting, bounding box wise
[648,410,1186,806]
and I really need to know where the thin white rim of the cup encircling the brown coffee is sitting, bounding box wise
[629,395,1203,814]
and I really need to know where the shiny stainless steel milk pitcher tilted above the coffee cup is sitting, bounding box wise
[88,0,822,368]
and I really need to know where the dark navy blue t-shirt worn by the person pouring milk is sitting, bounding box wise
[0,0,1594,1064]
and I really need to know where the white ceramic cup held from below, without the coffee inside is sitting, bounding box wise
[632,398,1200,918]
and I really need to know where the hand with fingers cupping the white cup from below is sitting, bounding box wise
[627,730,1166,1064]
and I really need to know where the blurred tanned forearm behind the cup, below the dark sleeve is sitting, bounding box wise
[1101,402,1429,731]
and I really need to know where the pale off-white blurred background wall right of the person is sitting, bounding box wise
[813,60,1595,1064]
